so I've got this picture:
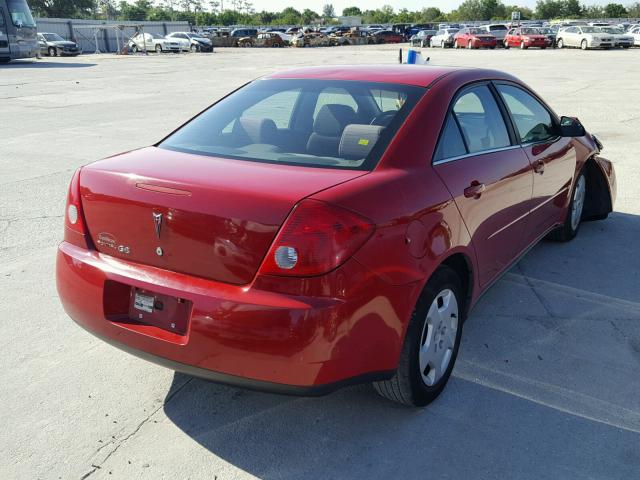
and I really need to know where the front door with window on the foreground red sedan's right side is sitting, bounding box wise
[496,83,577,244]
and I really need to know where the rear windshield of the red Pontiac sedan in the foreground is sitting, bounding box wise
[158,79,426,170]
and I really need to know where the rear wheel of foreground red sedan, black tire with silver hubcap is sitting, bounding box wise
[373,266,465,407]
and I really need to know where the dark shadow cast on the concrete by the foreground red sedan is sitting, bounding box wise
[164,213,640,479]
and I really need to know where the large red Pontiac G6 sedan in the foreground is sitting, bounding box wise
[57,65,616,405]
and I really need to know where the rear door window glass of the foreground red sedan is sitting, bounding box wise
[453,85,511,153]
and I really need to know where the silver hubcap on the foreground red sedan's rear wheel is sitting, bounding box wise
[418,288,459,387]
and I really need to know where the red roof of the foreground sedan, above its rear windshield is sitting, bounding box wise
[263,64,513,87]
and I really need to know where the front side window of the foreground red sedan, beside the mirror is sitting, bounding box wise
[498,85,557,143]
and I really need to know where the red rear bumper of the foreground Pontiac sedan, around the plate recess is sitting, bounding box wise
[56,242,417,395]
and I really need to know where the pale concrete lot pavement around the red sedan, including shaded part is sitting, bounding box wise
[0,46,640,480]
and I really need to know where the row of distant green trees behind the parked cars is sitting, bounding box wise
[29,0,640,25]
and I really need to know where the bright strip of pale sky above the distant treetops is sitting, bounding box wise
[224,0,620,15]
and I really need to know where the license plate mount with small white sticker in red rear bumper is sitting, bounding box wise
[128,287,191,335]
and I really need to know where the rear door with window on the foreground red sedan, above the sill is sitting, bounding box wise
[433,83,533,285]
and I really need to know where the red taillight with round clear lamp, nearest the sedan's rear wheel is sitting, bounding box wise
[260,200,374,277]
